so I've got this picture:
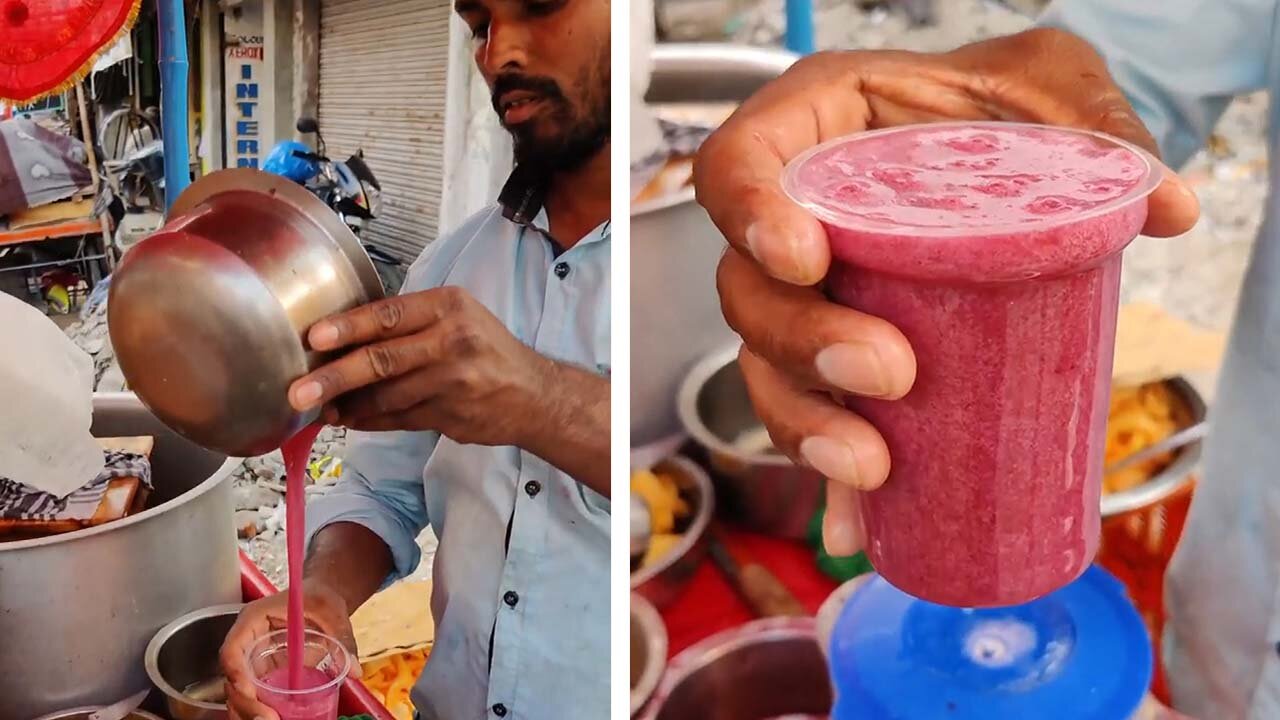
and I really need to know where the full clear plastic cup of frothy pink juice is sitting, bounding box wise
[783,123,1161,607]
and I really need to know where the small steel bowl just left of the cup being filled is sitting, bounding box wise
[143,605,244,720]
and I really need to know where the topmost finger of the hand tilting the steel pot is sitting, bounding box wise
[307,286,467,352]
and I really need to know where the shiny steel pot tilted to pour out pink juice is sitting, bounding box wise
[108,168,384,457]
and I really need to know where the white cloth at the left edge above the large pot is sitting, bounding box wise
[0,293,104,497]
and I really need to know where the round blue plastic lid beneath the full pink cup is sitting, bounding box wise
[829,566,1152,720]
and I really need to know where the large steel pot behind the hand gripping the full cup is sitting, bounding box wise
[631,45,796,447]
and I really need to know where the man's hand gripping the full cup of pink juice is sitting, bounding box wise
[694,29,1199,555]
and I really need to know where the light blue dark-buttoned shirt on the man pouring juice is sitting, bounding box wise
[307,205,611,720]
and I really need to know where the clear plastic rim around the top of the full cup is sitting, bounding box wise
[780,120,1164,240]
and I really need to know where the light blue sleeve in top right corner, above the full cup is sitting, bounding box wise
[1038,0,1276,168]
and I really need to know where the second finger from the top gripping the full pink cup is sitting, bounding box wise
[717,250,915,398]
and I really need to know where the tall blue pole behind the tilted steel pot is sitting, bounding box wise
[156,0,191,210]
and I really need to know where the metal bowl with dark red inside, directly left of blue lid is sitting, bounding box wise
[641,618,832,720]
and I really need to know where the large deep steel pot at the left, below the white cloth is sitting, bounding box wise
[0,393,241,720]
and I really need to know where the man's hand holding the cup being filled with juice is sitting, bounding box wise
[219,582,361,720]
